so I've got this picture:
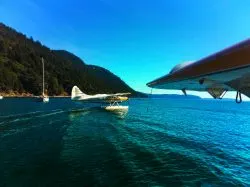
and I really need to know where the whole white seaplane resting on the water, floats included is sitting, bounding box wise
[71,86,130,113]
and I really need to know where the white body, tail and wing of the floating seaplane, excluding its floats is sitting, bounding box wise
[71,86,130,102]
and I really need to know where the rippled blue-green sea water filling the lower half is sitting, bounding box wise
[0,99,250,187]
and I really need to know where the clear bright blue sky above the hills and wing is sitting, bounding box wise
[0,0,250,97]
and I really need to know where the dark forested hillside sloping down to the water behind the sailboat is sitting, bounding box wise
[0,23,141,95]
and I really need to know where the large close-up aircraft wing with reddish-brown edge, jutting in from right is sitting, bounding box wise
[147,39,250,102]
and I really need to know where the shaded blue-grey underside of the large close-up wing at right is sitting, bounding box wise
[150,67,250,98]
